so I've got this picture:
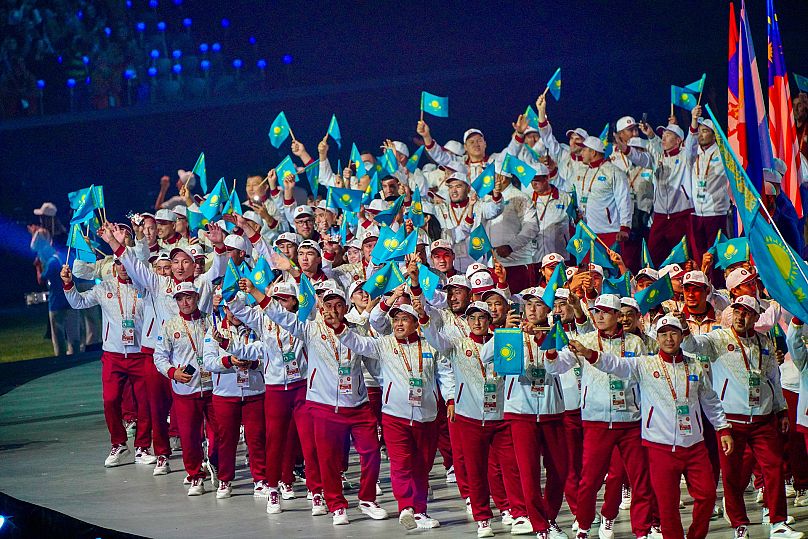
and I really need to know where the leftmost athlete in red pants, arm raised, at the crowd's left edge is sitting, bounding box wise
[61,260,157,467]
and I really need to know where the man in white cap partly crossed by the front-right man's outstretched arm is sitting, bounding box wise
[545,294,653,539]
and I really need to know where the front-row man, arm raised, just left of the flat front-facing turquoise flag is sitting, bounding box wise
[422,301,527,537]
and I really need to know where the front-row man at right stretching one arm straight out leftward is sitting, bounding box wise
[565,315,733,539]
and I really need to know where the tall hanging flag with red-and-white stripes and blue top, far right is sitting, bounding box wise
[766,0,803,218]
